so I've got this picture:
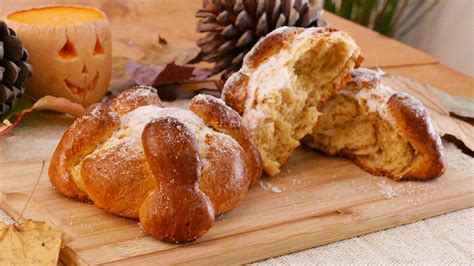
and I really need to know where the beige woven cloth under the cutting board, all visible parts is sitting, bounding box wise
[0,110,474,265]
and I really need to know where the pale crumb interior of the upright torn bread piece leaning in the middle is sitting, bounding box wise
[243,38,355,175]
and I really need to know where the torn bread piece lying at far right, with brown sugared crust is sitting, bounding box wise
[305,69,446,180]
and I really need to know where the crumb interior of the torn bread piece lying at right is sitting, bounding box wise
[309,93,415,177]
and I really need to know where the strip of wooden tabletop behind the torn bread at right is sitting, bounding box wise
[324,12,474,98]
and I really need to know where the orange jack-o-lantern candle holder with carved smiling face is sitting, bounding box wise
[5,6,112,106]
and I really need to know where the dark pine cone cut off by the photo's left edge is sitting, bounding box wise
[0,20,32,114]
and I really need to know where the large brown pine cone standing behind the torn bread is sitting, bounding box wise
[190,0,326,85]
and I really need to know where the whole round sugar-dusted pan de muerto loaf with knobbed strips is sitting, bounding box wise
[49,87,262,243]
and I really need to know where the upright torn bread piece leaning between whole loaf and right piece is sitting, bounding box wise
[222,27,362,175]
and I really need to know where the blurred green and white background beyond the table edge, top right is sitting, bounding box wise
[316,0,474,77]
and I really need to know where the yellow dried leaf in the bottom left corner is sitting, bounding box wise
[0,220,61,265]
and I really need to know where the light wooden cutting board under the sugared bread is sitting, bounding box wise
[0,77,474,264]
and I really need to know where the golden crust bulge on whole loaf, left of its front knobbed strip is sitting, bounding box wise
[81,141,156,219]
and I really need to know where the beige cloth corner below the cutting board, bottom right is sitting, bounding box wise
[255,208,474,265]
